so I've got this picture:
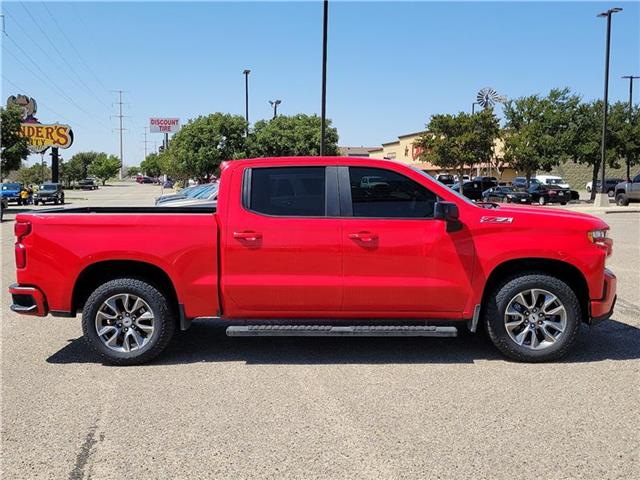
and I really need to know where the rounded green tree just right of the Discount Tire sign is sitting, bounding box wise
[168,113,246,179]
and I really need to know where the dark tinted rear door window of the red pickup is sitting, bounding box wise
[248,167,326,217]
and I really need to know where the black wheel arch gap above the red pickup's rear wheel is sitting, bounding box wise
[71,260,179,313]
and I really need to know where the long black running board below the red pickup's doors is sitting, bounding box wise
[227,325,458,337]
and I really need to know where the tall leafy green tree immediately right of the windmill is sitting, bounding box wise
[504,88,580,184]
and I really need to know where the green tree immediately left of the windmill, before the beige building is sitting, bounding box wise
[415,110,500,182]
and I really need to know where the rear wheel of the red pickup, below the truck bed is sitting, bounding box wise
[82,278,176,365]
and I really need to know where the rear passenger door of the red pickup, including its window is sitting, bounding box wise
[221,166,342,317]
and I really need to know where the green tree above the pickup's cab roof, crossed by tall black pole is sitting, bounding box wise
[248,114,338,157]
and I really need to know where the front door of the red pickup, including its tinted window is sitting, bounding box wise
[339,167,473,318]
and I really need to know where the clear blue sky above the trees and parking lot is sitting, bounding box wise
[2,1,640,165]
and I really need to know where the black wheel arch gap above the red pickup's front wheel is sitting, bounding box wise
[482,258,589,323]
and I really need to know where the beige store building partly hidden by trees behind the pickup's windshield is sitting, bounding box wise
[369,131,516,182]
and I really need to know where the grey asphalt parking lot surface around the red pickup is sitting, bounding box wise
[0,183,640,480]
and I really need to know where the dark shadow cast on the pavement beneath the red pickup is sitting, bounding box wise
[47,320,640,366]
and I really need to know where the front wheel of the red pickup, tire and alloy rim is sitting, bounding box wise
[483,272,582,363]
